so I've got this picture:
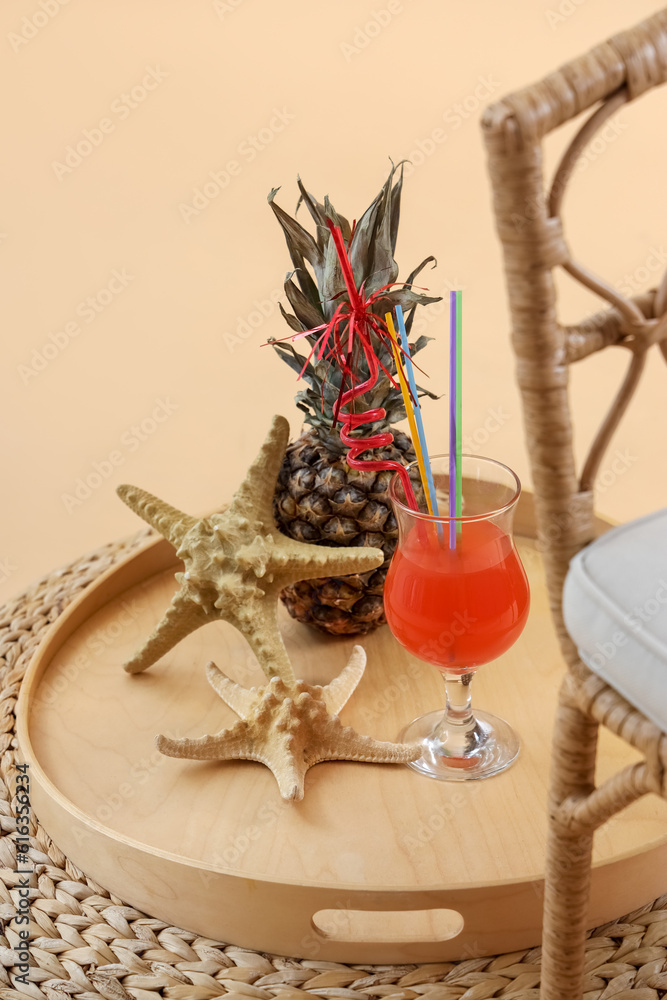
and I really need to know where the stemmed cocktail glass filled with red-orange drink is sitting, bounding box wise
[384,455,530,781]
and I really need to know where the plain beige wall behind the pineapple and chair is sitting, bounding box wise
[0,0,667,599]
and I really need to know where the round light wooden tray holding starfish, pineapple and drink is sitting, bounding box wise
[17,496,667,963]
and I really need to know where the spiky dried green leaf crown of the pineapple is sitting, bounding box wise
[268,164,440,431]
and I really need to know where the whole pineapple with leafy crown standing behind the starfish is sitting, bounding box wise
[269,166,439,635]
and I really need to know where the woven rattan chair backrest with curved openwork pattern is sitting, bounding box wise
[482,9,667,670]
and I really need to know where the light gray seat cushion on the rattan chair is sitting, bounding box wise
[563,509,667,731]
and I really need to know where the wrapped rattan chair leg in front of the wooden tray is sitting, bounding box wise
[540,678,598,1000]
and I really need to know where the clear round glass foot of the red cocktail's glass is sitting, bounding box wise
[400,709,521,781]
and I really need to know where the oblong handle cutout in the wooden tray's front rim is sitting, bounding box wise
[312,909,464,944]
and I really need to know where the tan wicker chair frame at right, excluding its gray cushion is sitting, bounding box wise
[482,10,667,1000]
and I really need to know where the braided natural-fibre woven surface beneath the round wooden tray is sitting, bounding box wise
[0,532,667,1000]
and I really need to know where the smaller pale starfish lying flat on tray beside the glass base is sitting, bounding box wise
[156,646,420,801]
